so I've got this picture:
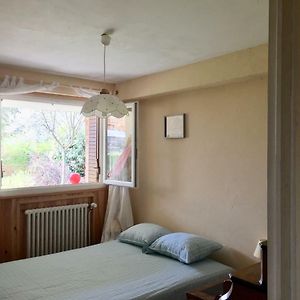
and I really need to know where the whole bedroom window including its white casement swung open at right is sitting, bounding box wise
[0,97,137,189]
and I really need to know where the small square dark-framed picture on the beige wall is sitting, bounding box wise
[165,114,185,139]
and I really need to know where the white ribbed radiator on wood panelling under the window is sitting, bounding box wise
[25,203,97,257]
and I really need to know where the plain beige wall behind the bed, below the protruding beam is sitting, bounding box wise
[132,76,267,267]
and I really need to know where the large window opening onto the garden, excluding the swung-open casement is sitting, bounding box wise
[1,100,98,189]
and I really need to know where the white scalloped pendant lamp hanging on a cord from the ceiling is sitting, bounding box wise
[81,33,128,118]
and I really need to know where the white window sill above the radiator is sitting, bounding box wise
[0,183,106,198]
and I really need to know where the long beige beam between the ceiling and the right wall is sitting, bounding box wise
[116,44,268,100]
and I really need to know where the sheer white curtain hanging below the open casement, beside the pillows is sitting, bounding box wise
[101,185,133,242]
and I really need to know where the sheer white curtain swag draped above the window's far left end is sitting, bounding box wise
[0,75,59,96]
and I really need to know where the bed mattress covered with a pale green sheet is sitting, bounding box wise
[0,241,232,300]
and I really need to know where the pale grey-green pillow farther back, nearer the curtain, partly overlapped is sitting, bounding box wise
[119,223,171,248]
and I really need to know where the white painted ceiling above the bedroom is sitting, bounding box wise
[0,0,268,82]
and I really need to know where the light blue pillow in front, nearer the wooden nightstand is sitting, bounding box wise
[146,232,222,264]
